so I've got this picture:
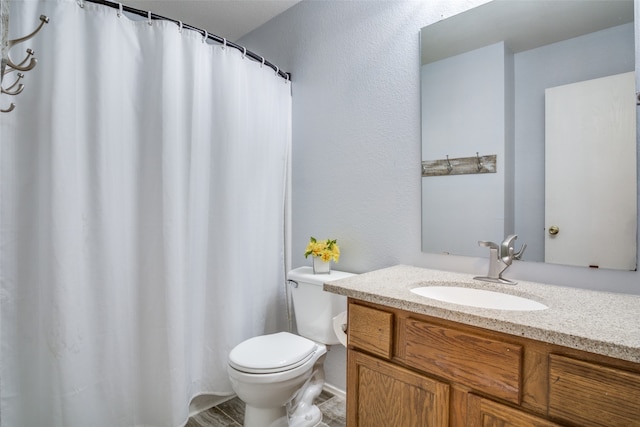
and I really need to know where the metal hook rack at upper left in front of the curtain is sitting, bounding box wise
[0,11,49,113]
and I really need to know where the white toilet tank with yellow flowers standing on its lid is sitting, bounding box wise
[287,267,354,344]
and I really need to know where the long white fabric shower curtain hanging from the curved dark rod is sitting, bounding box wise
[0,0,291,427]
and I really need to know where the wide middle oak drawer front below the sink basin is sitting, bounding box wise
[404,318,522,404]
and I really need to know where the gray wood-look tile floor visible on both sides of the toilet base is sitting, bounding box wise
[185,391,346,427]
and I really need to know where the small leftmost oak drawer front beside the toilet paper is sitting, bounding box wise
[348,304,393,359]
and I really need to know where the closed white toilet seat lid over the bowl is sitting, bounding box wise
[229,332,318,374]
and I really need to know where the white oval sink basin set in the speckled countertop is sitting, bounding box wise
[411,286,548,311]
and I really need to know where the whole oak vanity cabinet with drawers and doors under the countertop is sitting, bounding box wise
[347,298,640,427]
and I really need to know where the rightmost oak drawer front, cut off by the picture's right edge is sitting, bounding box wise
[549,354,640,427]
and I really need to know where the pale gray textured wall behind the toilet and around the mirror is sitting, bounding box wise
[239,0,640,388]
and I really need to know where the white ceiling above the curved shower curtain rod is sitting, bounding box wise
[127,0,300,42]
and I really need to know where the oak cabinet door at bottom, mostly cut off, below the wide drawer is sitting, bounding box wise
[467,394,560,427]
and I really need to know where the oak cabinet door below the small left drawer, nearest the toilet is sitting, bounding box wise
[347,350,449,427]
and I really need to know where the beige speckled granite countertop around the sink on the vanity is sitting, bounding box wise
[324,265,640,363]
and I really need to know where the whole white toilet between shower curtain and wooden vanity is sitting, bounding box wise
[227,267,352,427]
